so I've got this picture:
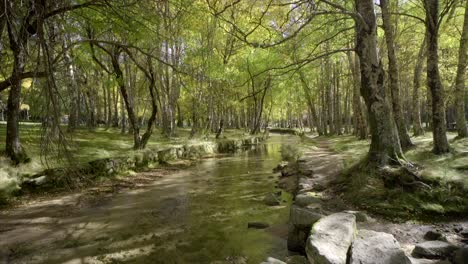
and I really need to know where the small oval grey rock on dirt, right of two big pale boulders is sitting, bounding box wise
[412,240,457,259]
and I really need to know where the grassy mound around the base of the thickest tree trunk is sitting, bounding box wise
[320,133,468,221]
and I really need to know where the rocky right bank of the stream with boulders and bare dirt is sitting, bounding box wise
[267,141,468,264]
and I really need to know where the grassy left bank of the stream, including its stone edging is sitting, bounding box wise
[0,123,256,203]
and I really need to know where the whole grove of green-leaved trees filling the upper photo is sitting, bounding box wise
[0,0,468,166]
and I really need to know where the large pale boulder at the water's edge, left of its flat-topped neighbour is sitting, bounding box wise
[306,213,356,264]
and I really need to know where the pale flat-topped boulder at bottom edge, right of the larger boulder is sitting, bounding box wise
[349,230,411,264]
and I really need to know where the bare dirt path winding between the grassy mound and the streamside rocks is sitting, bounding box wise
[296,138,468,254]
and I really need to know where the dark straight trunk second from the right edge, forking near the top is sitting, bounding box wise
[424,0,450,154]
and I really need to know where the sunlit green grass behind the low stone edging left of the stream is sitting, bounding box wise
[0,122,252,175]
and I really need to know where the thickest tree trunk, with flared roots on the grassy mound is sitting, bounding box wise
[355,0,403,167]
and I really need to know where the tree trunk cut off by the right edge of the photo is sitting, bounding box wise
[455,1,468,138]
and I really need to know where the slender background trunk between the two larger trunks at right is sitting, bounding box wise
[413,38,426,137]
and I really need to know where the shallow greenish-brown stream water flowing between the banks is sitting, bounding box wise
[0,136,297,263]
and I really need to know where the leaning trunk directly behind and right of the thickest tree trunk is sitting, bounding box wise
[380,0,413,149]
